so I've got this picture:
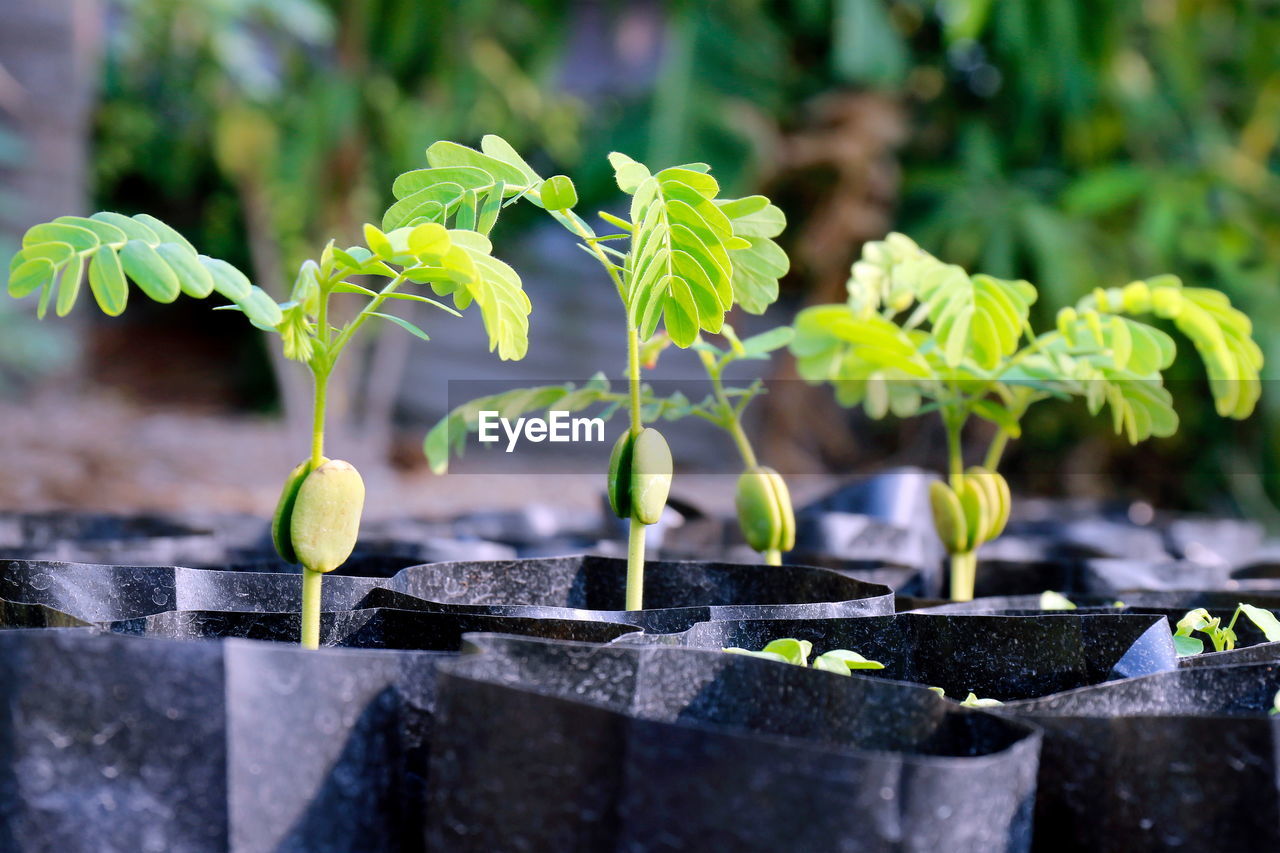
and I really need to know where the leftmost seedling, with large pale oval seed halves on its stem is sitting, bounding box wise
[9,141,540,648]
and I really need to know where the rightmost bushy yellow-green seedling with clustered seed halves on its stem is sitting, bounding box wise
[791,234,1262,601]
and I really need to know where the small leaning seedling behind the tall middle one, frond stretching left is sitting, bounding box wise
[425,323,796,566]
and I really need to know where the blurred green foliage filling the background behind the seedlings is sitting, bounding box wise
[0,0,1280,517]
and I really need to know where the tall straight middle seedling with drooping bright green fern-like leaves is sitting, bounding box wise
[426,137,787,610]
